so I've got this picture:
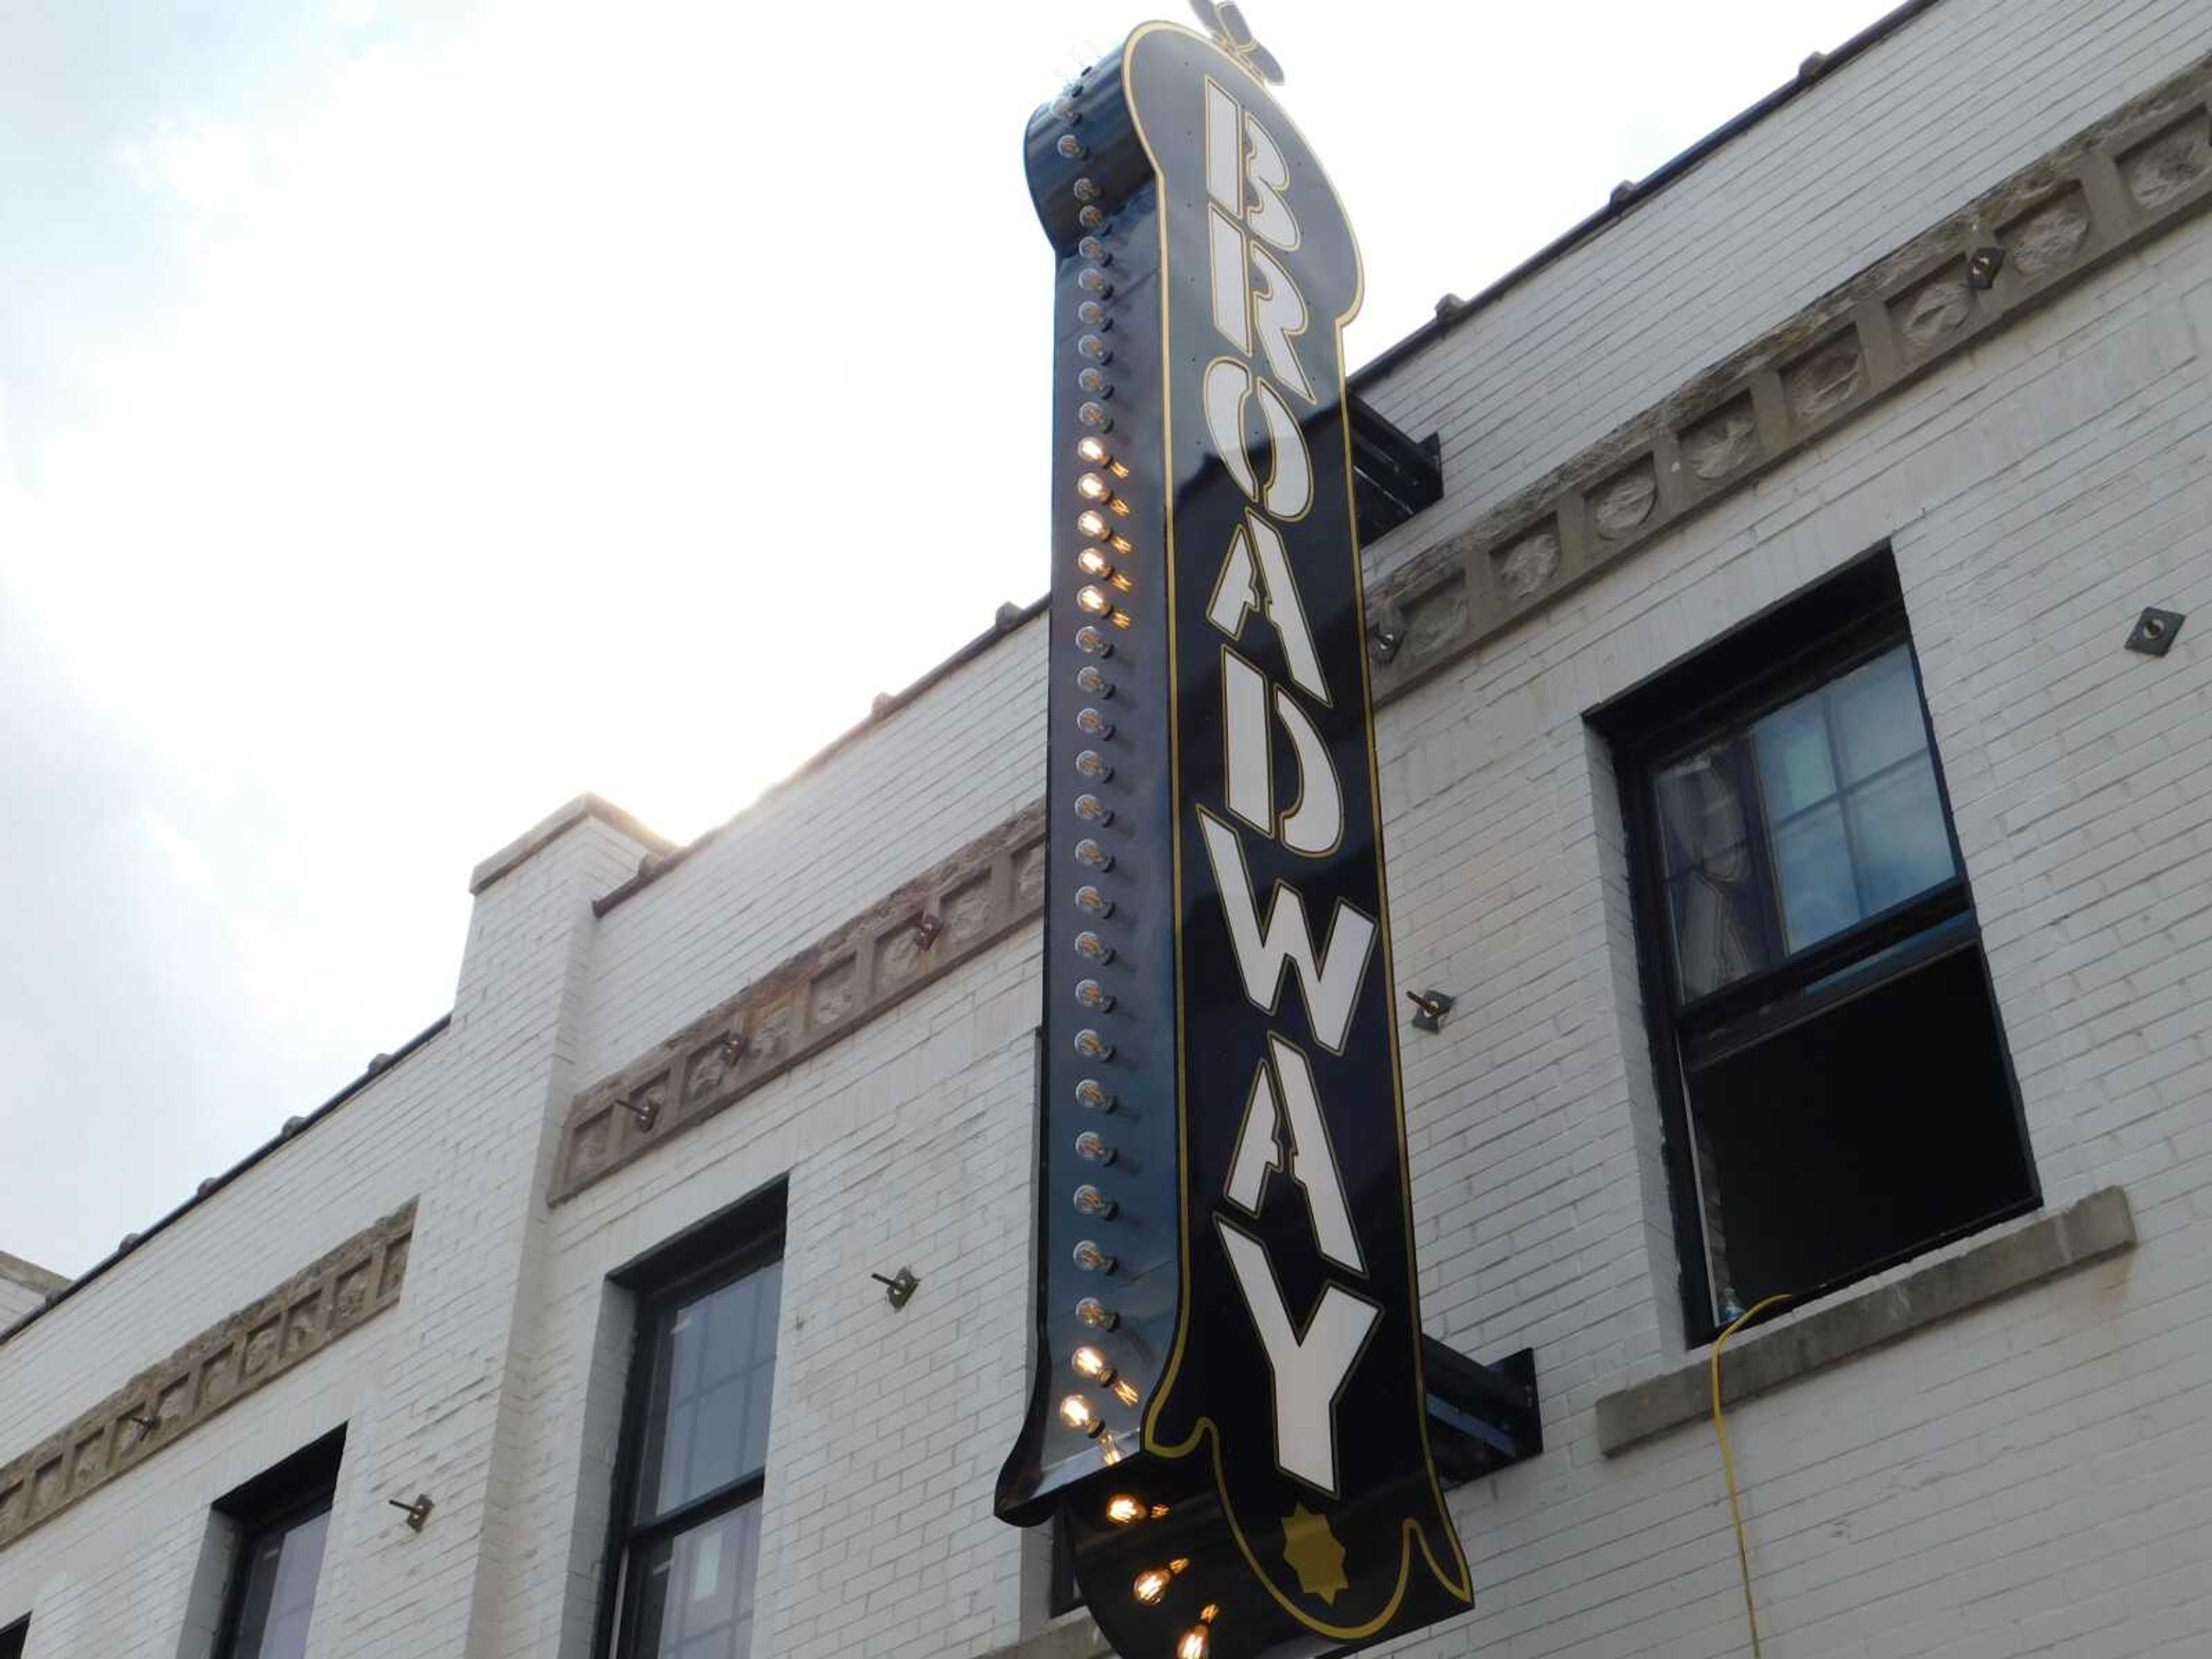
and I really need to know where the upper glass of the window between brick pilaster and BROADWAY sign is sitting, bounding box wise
[637,1263,783,1520]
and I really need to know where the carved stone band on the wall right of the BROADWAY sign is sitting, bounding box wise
[1369,58,2212,701]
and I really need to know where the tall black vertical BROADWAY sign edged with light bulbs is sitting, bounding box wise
[998,5,1471,1659]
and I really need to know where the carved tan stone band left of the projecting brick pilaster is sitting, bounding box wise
[0,1199,416,1551]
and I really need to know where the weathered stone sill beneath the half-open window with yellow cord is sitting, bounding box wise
[1597,1185,2135,1458]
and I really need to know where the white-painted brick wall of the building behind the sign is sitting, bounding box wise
[0,0,2212,1659]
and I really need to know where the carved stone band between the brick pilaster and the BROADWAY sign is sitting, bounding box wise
[551,801,1044,1203]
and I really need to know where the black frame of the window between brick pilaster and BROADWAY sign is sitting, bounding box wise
[593,1179,785,1659]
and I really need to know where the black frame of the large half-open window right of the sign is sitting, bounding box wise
[1590,546,2041,1347]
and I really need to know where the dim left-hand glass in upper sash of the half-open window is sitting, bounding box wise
[1659,745,1767,998]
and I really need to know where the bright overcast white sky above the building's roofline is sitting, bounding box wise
[0,0,1887,1272]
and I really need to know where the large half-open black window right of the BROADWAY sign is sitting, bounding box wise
[1599,555,2037,1340]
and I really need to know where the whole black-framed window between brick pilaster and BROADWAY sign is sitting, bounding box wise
[615,1190,783,1659]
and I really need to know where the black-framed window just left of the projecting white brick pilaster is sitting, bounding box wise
[212,1429,345,1659]
